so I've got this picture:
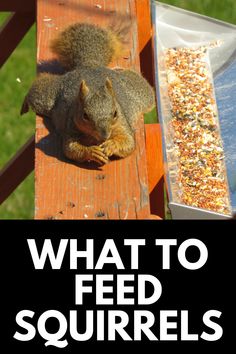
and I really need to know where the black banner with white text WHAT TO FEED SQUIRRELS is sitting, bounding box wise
[1,220,236,353]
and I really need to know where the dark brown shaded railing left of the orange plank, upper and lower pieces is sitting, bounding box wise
[0,0,36,204]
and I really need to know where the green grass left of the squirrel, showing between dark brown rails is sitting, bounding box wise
[0,14,36,219]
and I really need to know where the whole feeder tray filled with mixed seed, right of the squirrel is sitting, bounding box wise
[152,2,236,219]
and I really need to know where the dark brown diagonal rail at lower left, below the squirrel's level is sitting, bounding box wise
[0,135,35,204]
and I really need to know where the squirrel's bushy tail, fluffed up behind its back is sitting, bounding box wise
[51,23,128,70]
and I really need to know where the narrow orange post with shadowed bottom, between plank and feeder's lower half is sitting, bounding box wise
[145,123,165,218]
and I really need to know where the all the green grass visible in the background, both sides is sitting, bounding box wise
[0,0,236,219]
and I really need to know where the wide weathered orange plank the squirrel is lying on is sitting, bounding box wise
[35,0,150,219]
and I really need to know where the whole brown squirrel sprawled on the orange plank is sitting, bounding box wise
[21,23,155,165]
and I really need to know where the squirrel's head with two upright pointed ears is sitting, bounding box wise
[74,78,120,143]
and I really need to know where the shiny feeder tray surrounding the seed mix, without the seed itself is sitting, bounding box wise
[152,1,236,219]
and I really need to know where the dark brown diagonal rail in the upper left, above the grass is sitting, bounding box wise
[0,12,35,68]
